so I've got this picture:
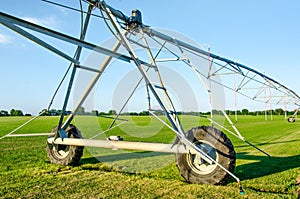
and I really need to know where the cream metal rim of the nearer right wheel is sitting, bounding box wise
[187,140,218,175]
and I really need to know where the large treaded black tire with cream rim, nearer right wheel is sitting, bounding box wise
[176,126,236,185]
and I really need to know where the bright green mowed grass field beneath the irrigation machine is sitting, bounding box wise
[0,116,300,198]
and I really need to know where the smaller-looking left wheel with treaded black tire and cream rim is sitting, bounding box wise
[46,124,84,165]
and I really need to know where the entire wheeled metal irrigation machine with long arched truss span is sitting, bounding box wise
[0,0,300,191]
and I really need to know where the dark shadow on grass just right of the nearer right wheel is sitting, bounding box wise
[234,153,300,180]
